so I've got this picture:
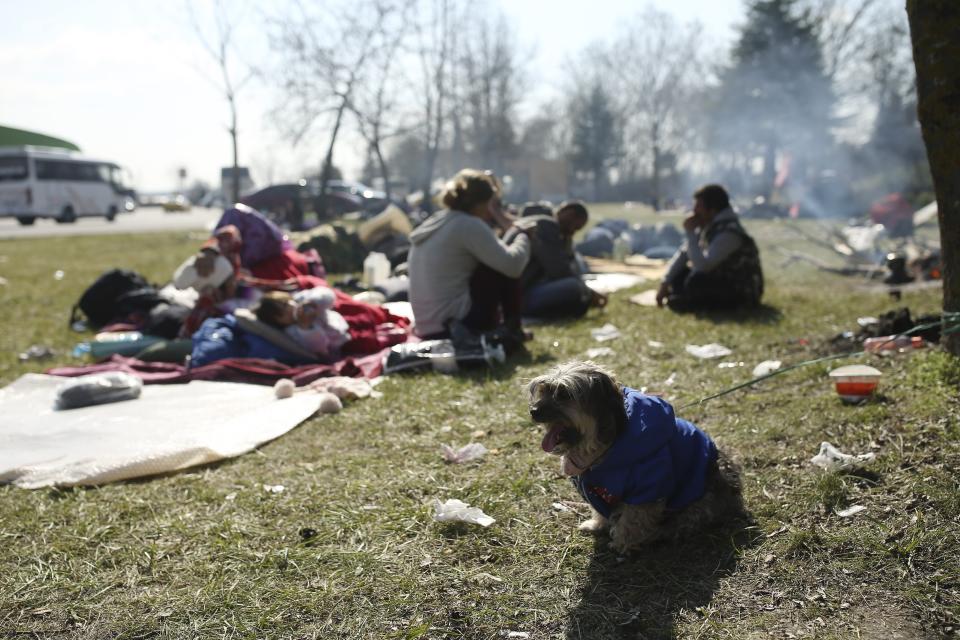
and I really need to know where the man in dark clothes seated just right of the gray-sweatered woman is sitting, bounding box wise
[504,201,607,318]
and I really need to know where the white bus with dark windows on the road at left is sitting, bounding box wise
[0,146,135,225]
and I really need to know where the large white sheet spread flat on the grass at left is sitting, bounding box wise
[0,374,318,489]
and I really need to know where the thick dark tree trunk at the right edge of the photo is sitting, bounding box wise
[907,0,960,356]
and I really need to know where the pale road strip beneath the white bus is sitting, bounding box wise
[0,207,223,239]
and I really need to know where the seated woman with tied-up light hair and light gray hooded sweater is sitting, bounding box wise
[408,169,530,346]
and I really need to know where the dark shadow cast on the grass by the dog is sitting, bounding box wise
[564,515,760,640]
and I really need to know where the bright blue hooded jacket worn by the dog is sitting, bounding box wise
[571,387,717,518]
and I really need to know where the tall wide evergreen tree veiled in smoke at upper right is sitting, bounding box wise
[709,0,834,198]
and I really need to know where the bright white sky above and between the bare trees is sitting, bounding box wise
[0,0,743,192]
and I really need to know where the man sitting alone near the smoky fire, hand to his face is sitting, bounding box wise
[657,184,763,311]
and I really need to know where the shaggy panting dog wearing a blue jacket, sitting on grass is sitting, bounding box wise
[527,361,743,554]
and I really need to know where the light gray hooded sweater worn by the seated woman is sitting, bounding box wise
[407,210,530,336]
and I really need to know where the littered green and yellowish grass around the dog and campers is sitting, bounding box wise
[0,207,960,639]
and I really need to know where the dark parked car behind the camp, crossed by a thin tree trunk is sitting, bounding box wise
[240,180,364,229]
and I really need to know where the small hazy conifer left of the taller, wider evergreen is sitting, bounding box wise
[569,76,622,199]
